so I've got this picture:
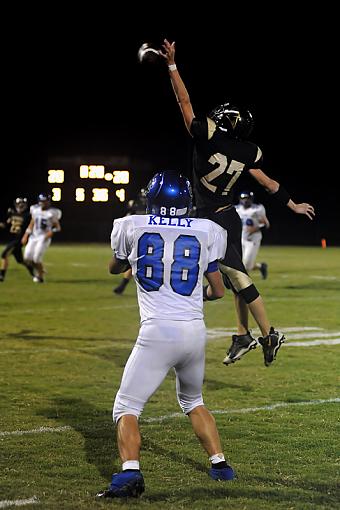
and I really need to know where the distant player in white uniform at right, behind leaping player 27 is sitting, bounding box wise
[236,191,270,280]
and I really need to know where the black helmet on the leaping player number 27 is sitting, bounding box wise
[209,103,254,138]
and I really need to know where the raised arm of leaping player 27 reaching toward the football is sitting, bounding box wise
[159,39,195,134]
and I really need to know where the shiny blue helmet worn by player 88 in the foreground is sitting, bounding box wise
[145,171,192,218]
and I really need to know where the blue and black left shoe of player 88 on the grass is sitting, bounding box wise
[96,469,145,498]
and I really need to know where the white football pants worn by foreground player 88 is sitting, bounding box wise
[113,320,206,422]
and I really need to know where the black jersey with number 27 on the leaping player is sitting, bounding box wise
[191,117,262,211]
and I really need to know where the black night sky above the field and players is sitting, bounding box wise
[0,4,340,244]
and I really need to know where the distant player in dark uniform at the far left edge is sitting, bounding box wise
[0,197,31,282]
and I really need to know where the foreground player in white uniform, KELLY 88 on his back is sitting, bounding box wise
[97,172,234,498]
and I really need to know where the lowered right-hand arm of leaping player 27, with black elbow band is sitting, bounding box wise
[249,168,315,220]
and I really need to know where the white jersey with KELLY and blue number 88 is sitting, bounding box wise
[111,214,227,322]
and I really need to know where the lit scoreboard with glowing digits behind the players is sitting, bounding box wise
[45,155,155,242]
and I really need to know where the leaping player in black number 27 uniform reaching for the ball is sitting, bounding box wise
[160,39,314,366]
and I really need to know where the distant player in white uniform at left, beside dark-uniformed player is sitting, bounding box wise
[21,193,62,283]
